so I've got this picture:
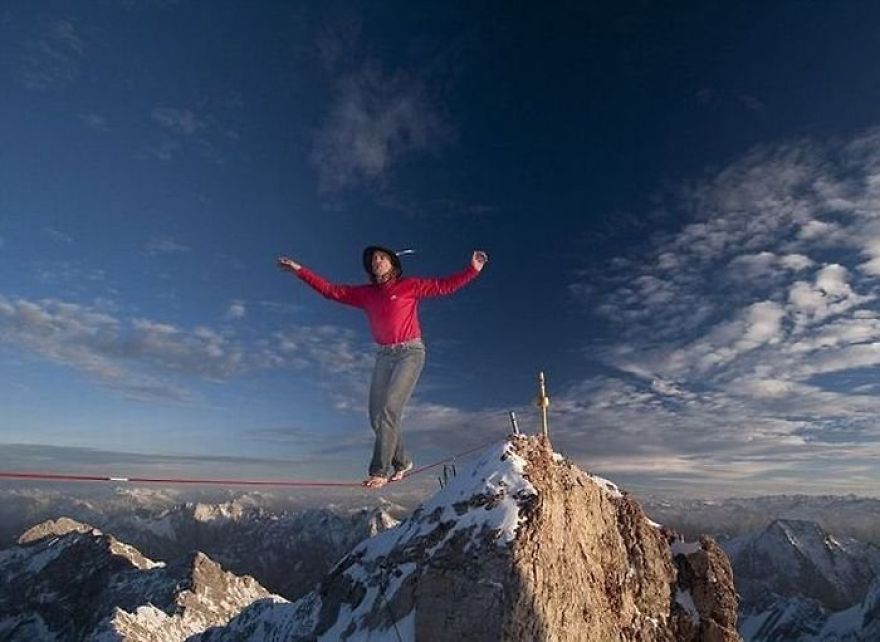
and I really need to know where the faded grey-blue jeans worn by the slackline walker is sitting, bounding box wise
[370,339,425,477]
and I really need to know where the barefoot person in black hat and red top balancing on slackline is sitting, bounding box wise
[278,245,489,488]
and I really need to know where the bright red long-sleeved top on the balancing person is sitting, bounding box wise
[296,265,479,345]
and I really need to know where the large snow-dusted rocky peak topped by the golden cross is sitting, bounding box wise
[199,438,739,642]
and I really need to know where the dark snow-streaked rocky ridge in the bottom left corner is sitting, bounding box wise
[0,518,270,642]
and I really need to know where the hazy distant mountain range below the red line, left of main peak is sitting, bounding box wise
[0,484,406,599]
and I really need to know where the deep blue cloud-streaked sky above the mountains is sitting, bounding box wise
[0,0,880,495]
